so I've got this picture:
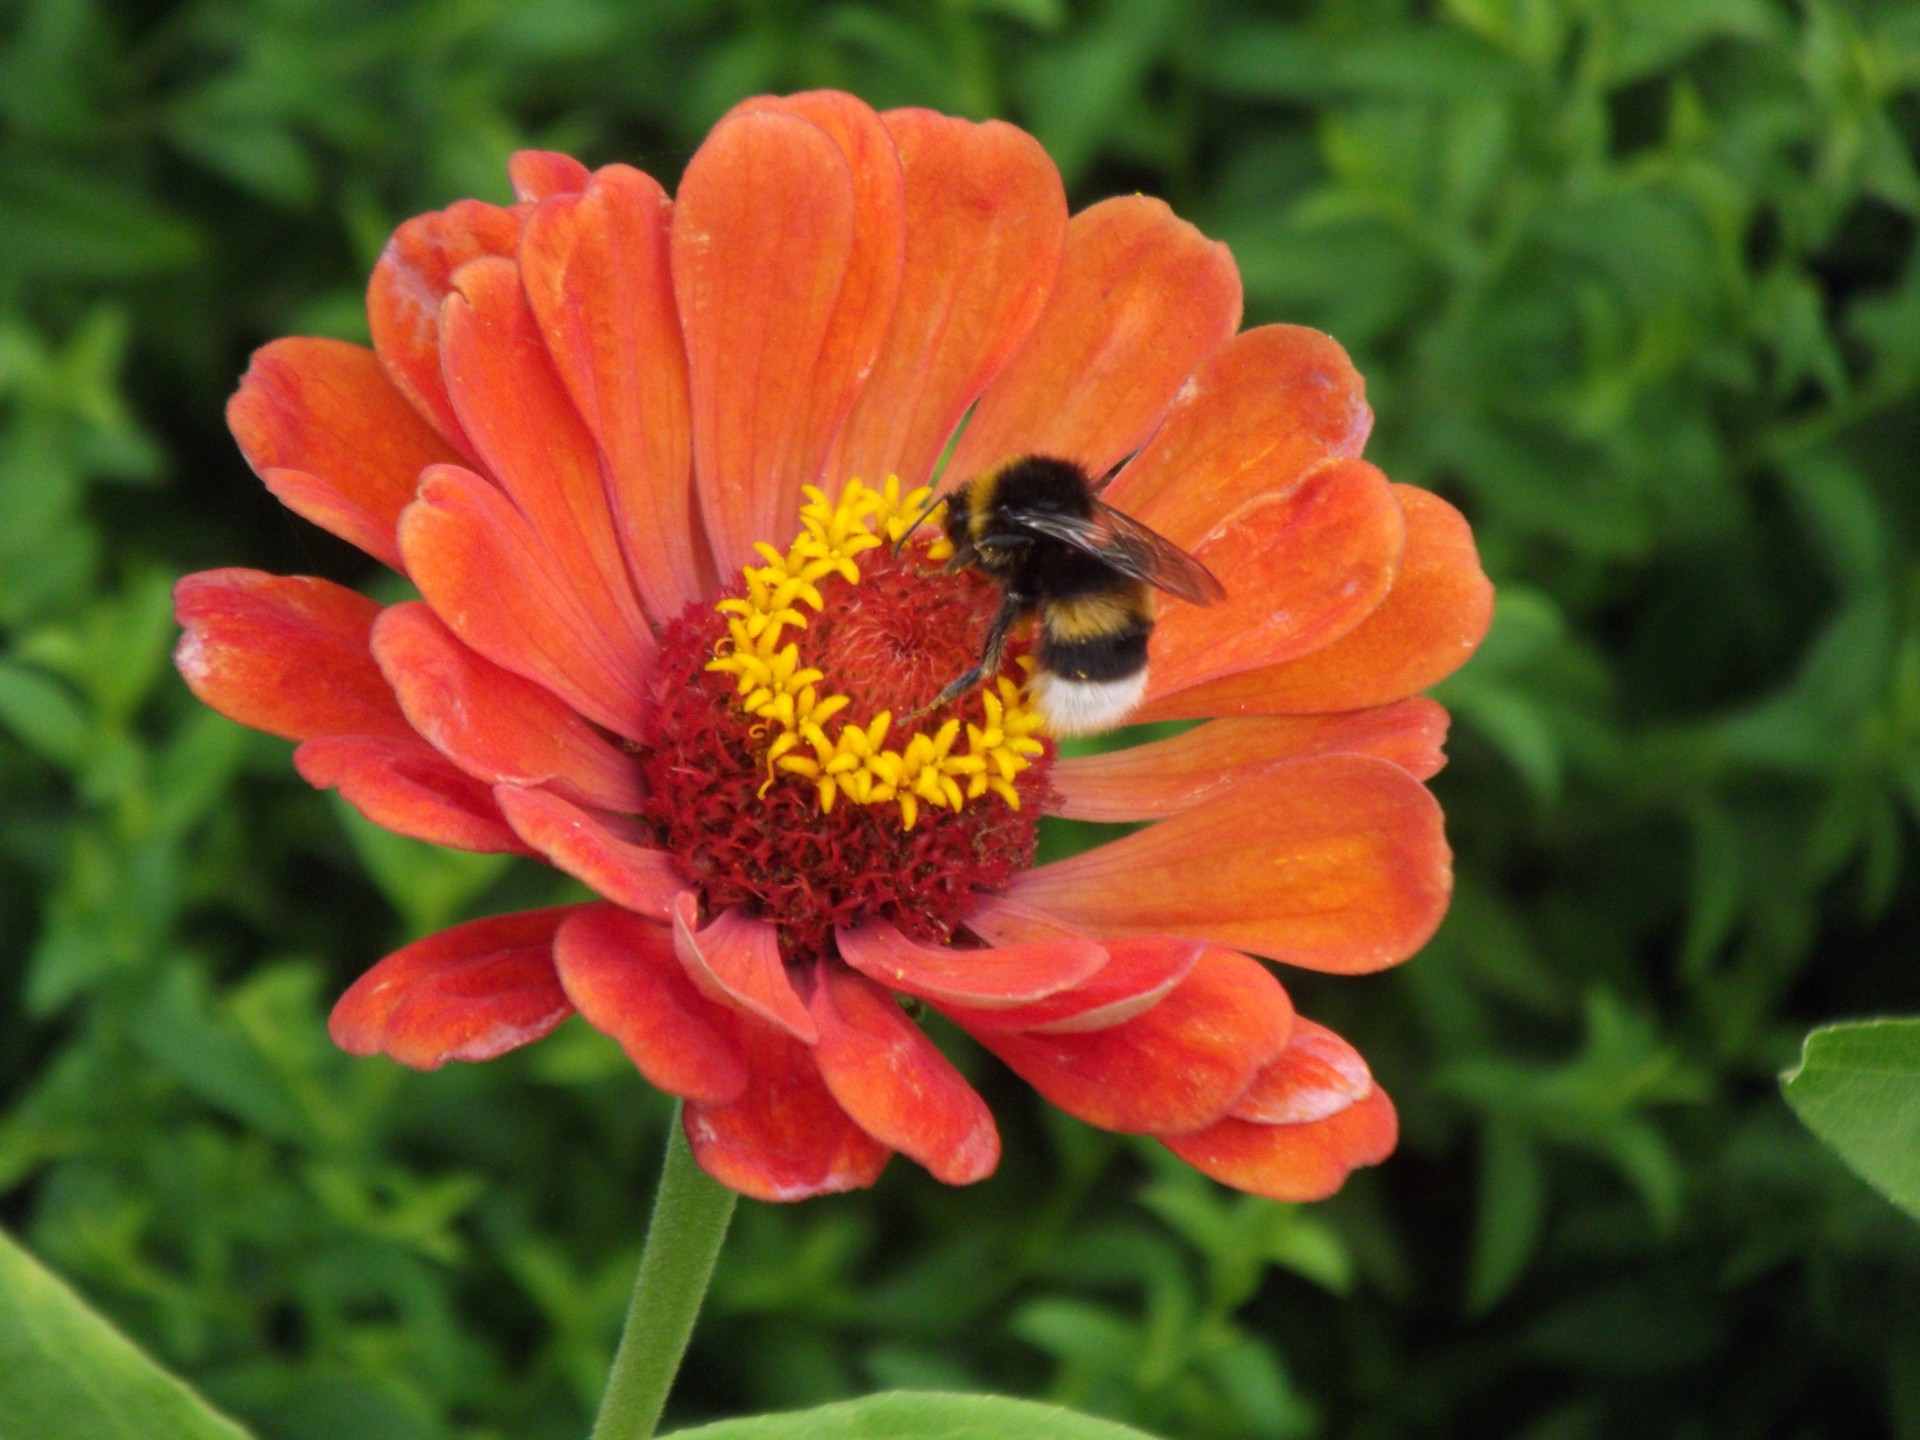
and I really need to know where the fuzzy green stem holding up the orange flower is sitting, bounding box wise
[593,1106,739,1440]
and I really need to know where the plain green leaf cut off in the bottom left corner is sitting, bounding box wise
[0,1233,255,1440]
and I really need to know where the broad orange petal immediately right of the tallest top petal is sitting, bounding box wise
[828,109,1068,490]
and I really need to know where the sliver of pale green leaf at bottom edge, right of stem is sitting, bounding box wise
[674,1392,1144,1440]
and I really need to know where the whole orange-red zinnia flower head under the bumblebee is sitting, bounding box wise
[179,92,1490,1200]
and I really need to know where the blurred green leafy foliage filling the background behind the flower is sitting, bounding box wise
[0,0,1920,1440]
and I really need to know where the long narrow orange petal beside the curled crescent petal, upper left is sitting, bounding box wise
[440,259,653,660]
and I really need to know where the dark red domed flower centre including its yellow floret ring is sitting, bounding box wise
[639,480,1054,962]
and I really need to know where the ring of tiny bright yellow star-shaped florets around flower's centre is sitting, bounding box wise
[707,476,1044,829]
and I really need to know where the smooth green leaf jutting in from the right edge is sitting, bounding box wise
[1780,1020,1920,1219]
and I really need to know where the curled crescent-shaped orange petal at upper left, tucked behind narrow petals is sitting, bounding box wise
[367,200,520,457]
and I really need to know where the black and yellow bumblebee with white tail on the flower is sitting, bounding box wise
[906,455,1227,735]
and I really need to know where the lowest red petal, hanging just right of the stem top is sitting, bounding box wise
[684,1016,893,1200]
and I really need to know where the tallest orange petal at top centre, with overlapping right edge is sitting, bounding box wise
[672,111,904,576]
